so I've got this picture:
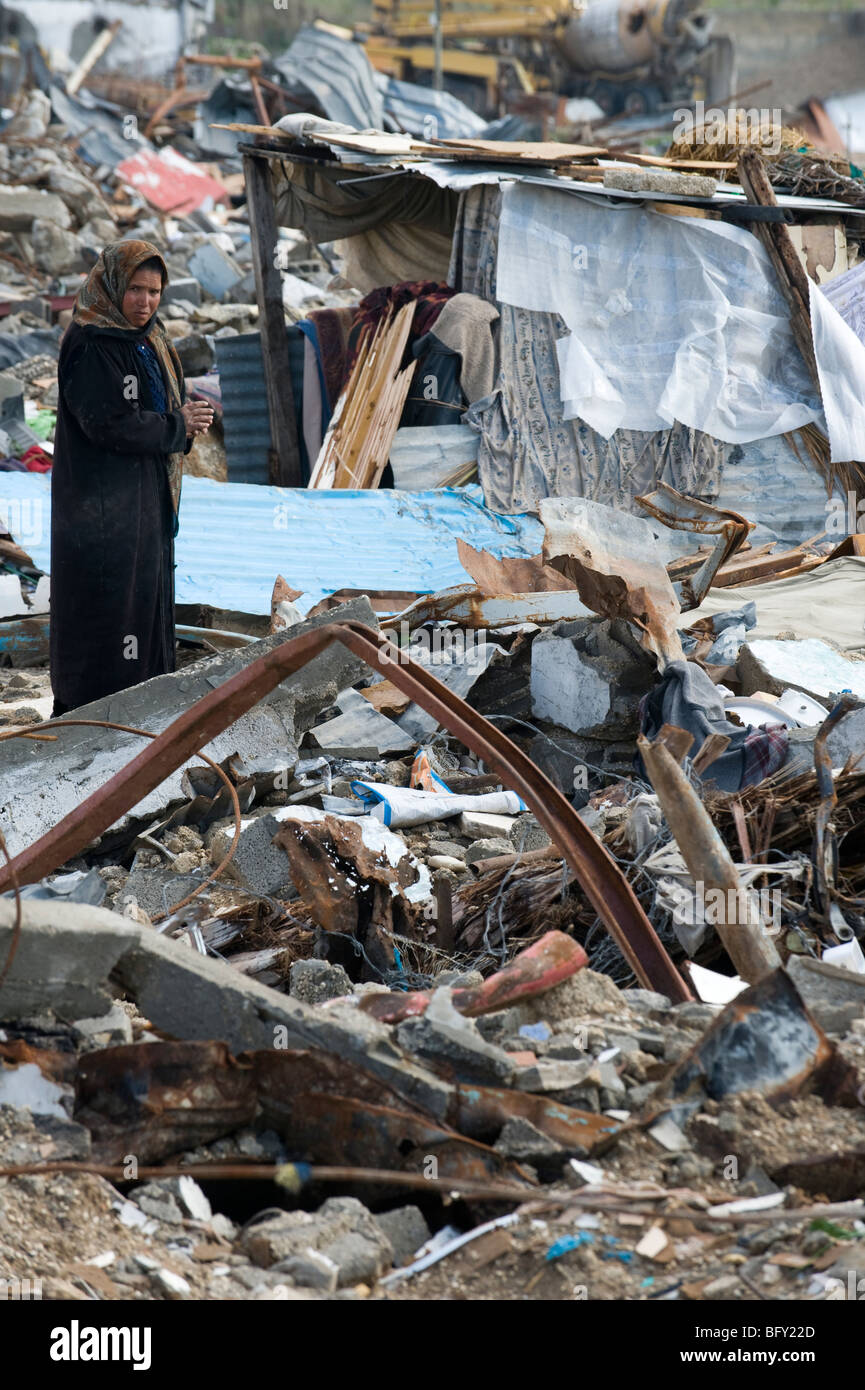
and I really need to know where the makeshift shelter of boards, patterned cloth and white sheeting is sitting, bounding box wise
[232,115,865,543]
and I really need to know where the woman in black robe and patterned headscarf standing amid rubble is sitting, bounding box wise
[50,242,213,719]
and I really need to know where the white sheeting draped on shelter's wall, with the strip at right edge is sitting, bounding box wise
[496,185,865,459]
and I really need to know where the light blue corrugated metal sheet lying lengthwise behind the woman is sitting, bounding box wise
[0,473,544,613]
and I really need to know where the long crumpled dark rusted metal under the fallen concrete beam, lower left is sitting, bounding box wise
[72,1043,524,1180]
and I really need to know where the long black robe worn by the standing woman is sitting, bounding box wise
[50,322,191,713]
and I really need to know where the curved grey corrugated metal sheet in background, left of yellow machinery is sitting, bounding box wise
[275,25,384,131]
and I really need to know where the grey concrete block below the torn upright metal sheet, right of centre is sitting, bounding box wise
[531,619,656,741]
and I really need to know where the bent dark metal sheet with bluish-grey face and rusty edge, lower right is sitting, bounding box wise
[652,970,858,1113]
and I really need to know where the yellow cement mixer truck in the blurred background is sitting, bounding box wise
[364,0,733,117]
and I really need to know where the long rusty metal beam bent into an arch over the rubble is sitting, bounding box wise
[0,623,691,1001]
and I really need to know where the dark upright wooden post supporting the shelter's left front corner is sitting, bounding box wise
[243,154,303,488]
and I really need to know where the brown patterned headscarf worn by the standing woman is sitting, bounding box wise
[72,242,184,516]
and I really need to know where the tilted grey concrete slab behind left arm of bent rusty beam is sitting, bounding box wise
[0,598,378,856]
